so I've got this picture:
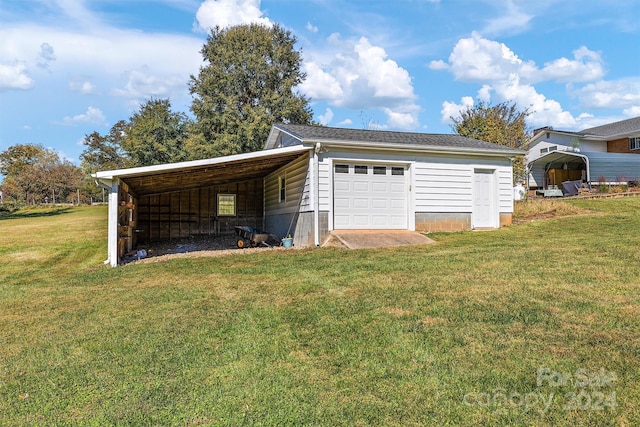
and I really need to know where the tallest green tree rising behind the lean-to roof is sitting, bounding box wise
[187,24,313,158]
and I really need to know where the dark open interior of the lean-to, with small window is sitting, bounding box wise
[112,152,306,258]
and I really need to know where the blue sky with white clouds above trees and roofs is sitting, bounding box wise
[0,0,640,163]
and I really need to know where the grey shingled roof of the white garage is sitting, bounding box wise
[275,123,523,154]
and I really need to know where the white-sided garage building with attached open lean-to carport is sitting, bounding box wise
[94,124,525,266]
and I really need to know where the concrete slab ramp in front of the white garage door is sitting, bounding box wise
[331,230,435,249]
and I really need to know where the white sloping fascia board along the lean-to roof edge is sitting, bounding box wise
[91,145,311,179]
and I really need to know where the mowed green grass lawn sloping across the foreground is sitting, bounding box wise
[0,198,640,426]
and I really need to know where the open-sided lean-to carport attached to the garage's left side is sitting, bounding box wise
[93,146,310,266]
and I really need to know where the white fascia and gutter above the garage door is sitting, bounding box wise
[303,138,527,157]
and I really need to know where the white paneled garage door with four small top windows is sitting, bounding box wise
[333,163,407,230]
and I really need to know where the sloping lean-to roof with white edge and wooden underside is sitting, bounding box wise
[93,146,312,197]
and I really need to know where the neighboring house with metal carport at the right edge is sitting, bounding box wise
[526,117,640,189]
